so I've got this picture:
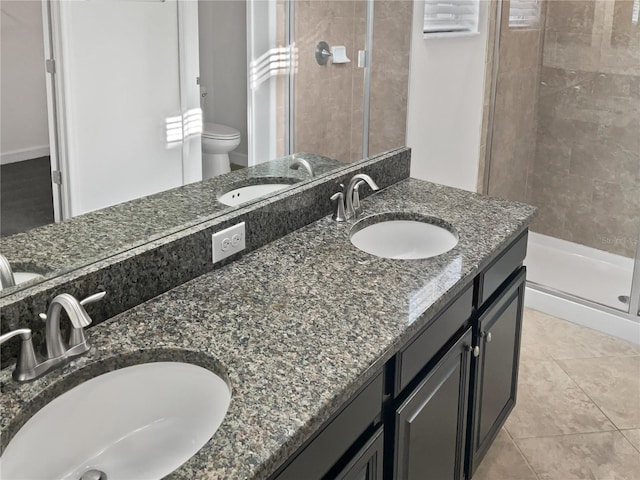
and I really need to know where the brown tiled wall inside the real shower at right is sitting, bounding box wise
[489,0,640,257]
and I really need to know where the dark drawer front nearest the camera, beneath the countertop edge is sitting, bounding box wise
[275,373,384,480]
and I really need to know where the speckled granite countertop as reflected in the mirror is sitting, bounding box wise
[0,153,346,296]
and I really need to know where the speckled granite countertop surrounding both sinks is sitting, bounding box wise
[0,179,535,479]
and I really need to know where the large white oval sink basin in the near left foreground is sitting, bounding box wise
[0,362,231,480]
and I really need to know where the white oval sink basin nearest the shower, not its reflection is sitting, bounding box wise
[351,216,458,260]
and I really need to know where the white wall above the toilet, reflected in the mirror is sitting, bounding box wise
[198,0,247,155]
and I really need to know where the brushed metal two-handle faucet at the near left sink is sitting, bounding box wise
[0,292,106,382]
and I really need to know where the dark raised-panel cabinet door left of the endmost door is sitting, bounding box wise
[394,329,472,480]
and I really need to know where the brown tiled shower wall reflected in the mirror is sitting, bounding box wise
[294,0,412,162]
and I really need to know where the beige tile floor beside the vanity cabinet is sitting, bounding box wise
[473,309,640,480]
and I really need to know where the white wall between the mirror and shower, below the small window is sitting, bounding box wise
[407,0,488,191]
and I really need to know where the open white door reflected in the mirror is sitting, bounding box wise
[51,0,184,218]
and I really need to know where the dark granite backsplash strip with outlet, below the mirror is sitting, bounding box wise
[0,148,411,367]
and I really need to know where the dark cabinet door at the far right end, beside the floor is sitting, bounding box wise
[470,267,525,472]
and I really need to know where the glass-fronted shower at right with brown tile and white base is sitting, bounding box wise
[486,0,640,331]
